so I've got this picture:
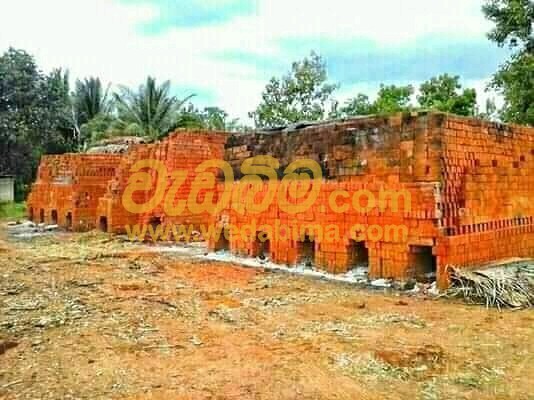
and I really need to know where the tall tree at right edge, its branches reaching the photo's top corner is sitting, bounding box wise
[483,0,534,125]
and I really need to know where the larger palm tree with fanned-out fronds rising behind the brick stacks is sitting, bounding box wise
[114,76,192,139]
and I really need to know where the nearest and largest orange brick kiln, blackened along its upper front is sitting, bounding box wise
[211,113,534,286]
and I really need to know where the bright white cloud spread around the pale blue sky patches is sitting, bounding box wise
[0,0,502,118]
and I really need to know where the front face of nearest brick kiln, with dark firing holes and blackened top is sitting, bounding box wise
[212,112,440,278]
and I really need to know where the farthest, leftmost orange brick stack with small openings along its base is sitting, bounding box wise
[28,154,121,231]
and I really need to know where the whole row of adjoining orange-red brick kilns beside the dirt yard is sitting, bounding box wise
[29,113,534,286]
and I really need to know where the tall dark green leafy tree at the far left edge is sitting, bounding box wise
[0,48,74,196]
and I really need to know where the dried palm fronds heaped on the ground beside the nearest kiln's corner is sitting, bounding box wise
[444,263,534,309]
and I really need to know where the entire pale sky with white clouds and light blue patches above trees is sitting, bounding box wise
[0,0,507,119]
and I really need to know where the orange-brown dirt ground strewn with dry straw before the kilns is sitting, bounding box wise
[0,226,534,400]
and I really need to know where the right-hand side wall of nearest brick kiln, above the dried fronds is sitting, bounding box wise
[436,117,534,284]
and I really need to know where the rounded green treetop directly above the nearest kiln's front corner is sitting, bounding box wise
[417,74,477,116]
